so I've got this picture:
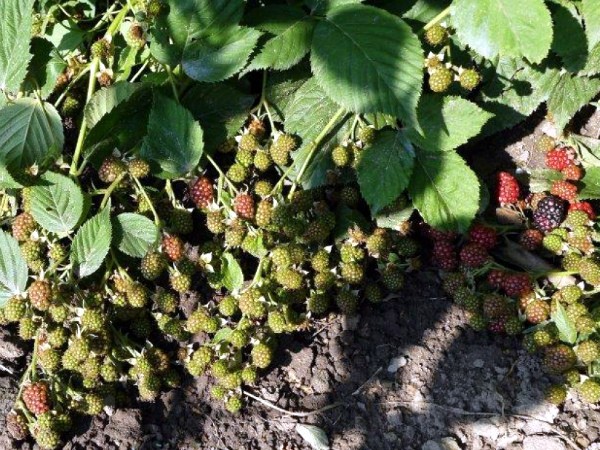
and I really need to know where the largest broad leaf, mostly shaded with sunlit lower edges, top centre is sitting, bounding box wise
[311,4,423,124]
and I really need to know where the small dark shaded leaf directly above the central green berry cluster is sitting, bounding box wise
[181,83,255,152]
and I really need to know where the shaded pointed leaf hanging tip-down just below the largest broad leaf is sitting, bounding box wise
[356,130,415,214]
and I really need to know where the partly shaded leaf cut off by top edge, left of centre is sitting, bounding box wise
[150,0,245,66]
